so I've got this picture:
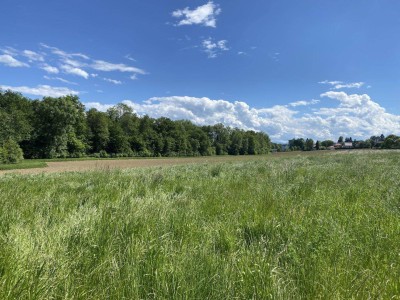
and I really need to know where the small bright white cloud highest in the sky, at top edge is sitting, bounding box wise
[172,1,221,28]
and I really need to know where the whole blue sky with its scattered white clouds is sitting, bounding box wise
[0,0,400,142]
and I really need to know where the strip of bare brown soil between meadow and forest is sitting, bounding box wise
[0,156,268,175]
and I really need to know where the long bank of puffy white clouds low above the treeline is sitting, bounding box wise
[85,91,400,142]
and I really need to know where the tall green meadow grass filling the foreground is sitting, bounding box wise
[0,151,400,299]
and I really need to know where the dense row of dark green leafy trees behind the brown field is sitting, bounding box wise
[0,90,270,162]
